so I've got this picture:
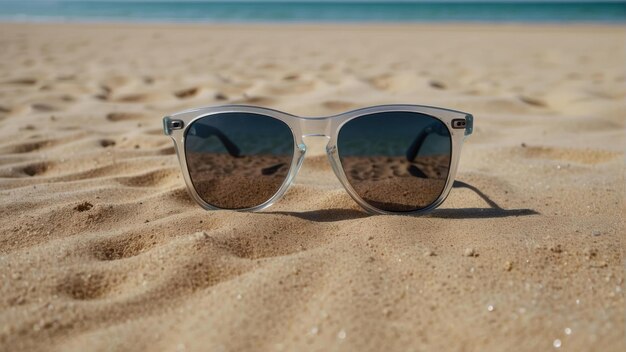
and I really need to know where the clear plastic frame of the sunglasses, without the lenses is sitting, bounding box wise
[163,105,473,215]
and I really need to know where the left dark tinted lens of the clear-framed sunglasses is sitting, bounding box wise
[185,113,294,209]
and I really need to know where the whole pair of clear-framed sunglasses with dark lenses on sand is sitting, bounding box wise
[163,105,473,214]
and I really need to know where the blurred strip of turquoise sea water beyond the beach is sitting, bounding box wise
[0,0,626,23]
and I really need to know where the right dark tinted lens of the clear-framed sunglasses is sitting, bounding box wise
[337,112,452,212]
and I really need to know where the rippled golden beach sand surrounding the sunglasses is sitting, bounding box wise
[0,24,626,351]
